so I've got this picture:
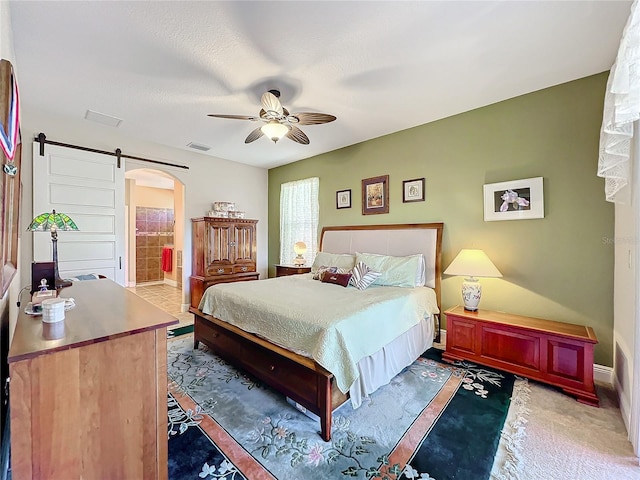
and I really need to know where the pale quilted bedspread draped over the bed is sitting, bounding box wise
[198,274,439,393]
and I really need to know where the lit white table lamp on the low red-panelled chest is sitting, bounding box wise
[444,248,502,312]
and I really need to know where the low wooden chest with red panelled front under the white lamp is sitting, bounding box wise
[442,306,599,406]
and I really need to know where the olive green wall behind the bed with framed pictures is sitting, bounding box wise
[269,72,614,366]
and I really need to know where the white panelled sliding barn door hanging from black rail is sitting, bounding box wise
[33,142,125,286]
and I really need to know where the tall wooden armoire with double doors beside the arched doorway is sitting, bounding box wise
[189,217,260,308]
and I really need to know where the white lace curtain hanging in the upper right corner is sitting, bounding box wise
[598,0,640,203]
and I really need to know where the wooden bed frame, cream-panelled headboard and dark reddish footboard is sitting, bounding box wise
[189,223,443,441]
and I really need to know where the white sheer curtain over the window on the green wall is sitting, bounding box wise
[280,177,320,265]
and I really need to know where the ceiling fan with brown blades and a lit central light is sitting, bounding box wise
[208,90,336,145]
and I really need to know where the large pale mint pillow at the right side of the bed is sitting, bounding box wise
[356,253,424,287]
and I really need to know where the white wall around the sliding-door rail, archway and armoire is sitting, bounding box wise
[20,107,268,303]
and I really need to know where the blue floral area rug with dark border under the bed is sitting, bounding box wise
[168,336,515,480]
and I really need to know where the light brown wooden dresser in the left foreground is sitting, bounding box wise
[8,279,178,480]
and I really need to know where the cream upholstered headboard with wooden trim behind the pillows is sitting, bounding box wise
[320,223,444,316]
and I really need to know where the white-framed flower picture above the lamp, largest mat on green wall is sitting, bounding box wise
[484,177,544,222]
